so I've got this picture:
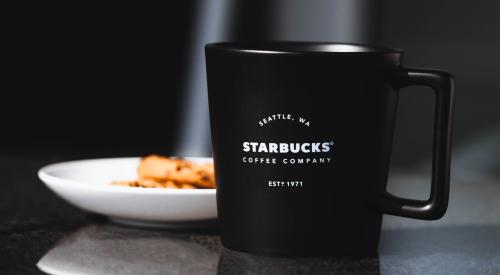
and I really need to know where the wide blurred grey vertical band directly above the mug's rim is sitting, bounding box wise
[270,0,376,43]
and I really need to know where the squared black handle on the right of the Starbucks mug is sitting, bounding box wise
[378,68,455,220]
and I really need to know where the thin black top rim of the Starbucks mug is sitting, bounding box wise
[205,41,403,54]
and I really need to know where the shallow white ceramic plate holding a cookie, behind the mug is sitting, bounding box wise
[38,158,217,227]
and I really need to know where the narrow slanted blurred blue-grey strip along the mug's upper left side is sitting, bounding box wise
[175,0,234,156]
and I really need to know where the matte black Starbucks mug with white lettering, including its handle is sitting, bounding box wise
[206,42,454,255]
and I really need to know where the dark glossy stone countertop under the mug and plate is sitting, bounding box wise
[0,155,500,274]
